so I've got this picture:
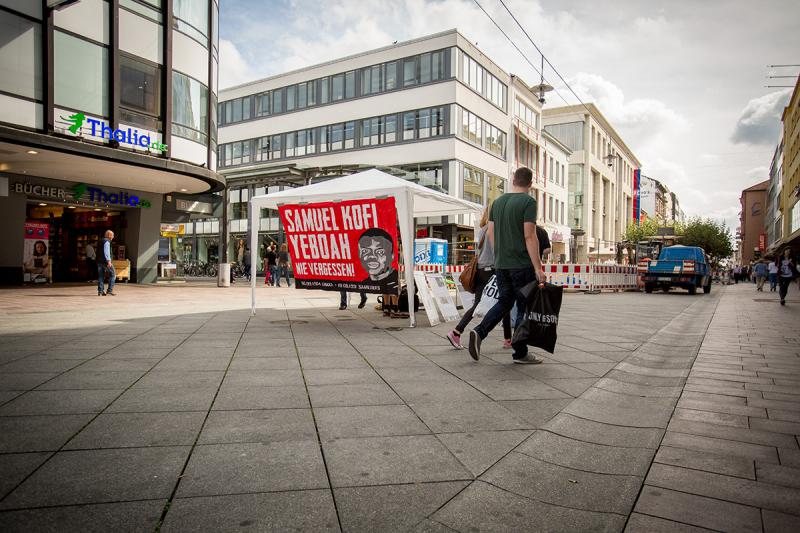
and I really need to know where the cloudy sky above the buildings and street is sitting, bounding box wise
[220,0,800,228]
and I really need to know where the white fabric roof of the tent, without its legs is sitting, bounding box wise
[250,169,483,217]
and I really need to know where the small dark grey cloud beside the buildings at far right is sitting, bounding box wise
[731,89,792,145]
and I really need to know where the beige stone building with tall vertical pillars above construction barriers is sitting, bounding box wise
[543,103,641,263]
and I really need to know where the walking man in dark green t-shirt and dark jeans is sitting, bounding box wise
[469,167,545,365]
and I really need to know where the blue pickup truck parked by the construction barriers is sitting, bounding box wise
[642,246,711,294]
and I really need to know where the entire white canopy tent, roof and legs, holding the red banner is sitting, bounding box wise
[250,169,483,327]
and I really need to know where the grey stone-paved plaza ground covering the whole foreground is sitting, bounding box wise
[0,284,800,532]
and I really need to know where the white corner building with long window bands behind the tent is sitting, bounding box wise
[219,30,510,261]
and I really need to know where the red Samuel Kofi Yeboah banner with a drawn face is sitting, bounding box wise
[278,198,399,294]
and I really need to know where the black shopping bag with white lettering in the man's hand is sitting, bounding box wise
[511,281,564,353]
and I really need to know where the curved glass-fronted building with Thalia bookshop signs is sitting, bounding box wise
[0,0,225,283]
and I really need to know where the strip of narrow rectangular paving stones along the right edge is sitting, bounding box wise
[628,284,800,531]
